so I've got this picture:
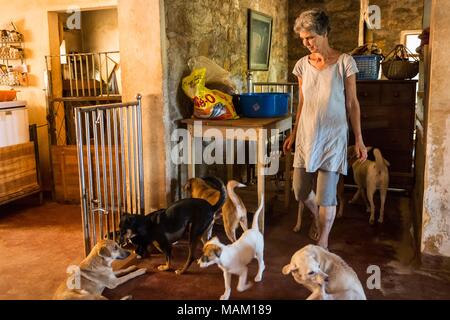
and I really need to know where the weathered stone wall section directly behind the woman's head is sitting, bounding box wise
[288,0,360,81]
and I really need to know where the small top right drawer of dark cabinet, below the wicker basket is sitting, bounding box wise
[381,82,416,106]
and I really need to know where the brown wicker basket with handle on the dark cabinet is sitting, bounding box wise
[381,45,419,80]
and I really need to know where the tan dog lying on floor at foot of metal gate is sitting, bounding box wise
[53,240,146,300]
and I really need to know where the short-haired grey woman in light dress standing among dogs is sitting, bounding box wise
[283,9,367,248]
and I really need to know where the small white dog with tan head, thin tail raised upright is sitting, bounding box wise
[198,195,265,300]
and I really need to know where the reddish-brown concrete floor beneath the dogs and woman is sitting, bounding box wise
[0,188,450,300]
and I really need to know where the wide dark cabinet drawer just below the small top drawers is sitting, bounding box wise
[361,106,414,132]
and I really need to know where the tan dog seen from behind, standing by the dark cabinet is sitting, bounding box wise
[347,146,389,224]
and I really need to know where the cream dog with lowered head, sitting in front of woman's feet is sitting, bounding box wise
[282,245,366,300]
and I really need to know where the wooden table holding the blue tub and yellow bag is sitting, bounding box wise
[181,115,292,232]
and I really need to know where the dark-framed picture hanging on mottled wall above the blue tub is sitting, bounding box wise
[248,9,273,71]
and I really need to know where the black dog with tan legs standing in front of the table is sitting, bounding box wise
[120,178,226,274]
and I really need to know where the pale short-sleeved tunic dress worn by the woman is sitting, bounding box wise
[292,53,358,175]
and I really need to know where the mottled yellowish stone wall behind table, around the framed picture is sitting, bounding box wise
[163,0,288,198]
